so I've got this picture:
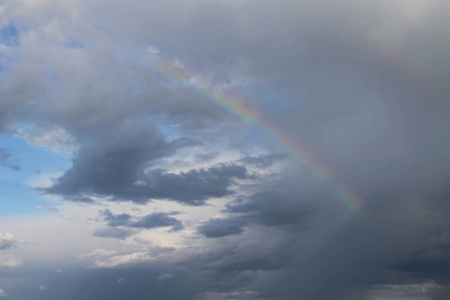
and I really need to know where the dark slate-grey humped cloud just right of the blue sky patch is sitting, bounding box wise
[40,120,178,203]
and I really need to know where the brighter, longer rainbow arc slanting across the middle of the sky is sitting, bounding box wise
[147,60,361,212]
